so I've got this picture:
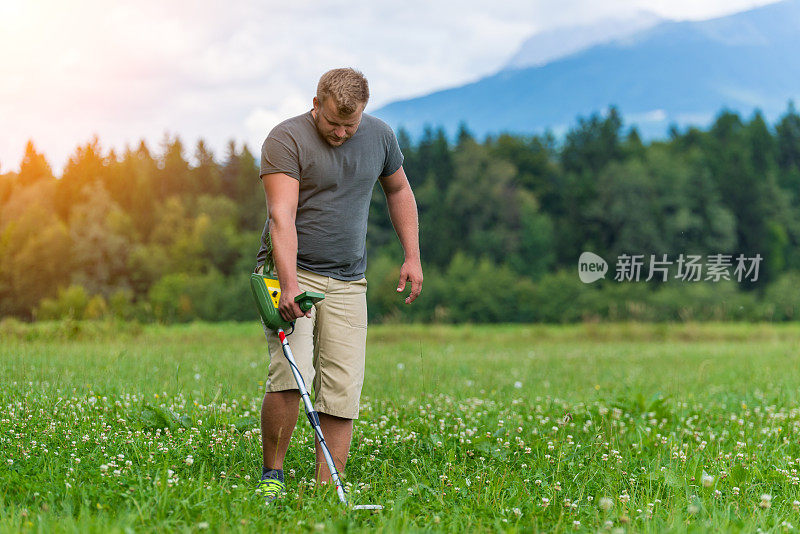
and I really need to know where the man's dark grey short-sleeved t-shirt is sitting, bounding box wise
[257,111,403,280]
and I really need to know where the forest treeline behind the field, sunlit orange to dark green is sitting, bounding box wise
[0,104,800,322]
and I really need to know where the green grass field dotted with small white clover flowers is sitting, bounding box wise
[0,321,800,532]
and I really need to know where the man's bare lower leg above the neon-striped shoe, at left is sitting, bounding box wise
[261,389,302,470]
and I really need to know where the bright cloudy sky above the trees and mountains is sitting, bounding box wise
[0,0,773,175]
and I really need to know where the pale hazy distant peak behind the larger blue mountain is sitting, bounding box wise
[503,11,664,70]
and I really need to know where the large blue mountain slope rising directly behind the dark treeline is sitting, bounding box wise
[373,0,800,138]
